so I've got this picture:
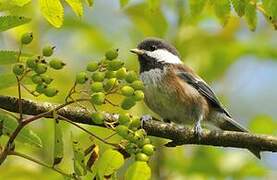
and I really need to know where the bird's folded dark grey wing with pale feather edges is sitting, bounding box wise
[177,72,231,117]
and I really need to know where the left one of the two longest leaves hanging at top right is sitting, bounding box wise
[213,0,231,26]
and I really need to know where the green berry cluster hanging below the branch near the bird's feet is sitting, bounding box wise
[116,114,155,162]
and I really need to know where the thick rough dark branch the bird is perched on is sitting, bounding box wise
[0,95,277,155]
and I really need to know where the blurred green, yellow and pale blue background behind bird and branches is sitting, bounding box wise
[0,0,277,180]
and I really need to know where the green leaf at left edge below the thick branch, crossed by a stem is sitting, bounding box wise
[0,113,42,148]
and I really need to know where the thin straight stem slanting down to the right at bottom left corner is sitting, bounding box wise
[8,151,74,178]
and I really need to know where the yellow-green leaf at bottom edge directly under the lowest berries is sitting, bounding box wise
[125,161,151,180]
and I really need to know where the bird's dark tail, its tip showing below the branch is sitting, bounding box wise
[210,113,261,159]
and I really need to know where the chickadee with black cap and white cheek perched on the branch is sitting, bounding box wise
[130,38,261,159]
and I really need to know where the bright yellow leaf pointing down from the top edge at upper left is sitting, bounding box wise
[39,0,64,28]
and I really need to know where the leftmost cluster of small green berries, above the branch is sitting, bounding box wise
[13,33,65,97]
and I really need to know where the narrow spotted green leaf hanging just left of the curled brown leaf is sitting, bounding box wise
[71,134,87,176]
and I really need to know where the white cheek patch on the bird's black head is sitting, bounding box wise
[146,49,182,64]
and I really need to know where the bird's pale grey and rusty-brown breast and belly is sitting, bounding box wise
[140,69,206,124]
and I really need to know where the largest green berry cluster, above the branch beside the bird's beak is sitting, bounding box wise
[76,49,144,110]
